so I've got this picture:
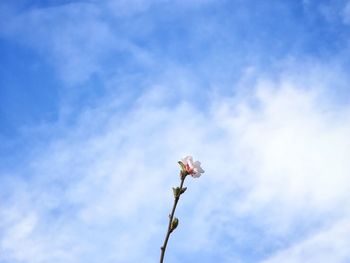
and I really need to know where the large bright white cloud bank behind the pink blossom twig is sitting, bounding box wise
[0,55,350,263]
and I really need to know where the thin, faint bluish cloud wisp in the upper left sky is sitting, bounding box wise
[0,3,152,86]
